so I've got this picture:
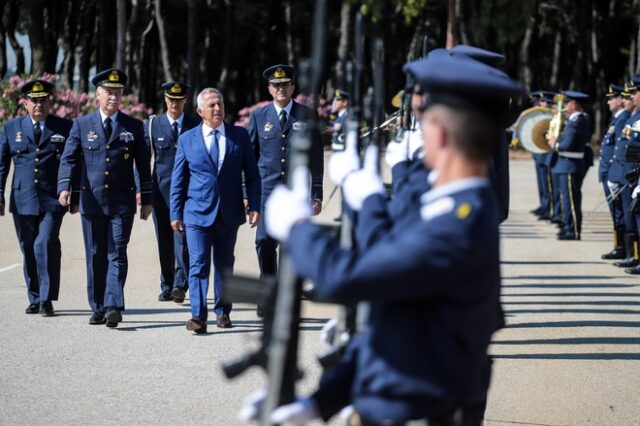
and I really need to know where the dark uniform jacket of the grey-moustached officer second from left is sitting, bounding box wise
[58,110,151,215]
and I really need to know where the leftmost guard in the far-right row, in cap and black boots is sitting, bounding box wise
[598,84,631,259]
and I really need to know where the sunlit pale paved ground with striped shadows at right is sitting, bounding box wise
[0,160,640,425]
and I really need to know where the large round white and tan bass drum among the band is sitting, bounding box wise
[511,107,554,154]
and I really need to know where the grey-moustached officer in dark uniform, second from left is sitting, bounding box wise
[58,69,151,327]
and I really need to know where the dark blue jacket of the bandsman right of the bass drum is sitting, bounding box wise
[553,112,591,173]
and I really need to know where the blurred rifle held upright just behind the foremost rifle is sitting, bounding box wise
[317,12,364,370]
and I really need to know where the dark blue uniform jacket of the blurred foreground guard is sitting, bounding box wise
[288,179,502,423]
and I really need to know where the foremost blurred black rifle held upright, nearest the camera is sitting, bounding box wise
[222,0,326,426]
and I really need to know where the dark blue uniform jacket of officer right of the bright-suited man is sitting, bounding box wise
[247,101,324,201]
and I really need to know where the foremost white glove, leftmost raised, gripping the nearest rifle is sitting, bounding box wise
[264,166,311,242]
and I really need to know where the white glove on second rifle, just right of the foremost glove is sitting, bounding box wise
[342,145,384,211]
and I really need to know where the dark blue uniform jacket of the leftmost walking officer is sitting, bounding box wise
[0,115,73,215]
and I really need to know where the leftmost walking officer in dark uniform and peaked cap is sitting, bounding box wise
[0,80,72,316]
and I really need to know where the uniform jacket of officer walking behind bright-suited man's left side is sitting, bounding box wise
[144,114,200,206]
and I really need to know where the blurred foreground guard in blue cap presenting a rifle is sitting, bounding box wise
[245,55,522,425]
